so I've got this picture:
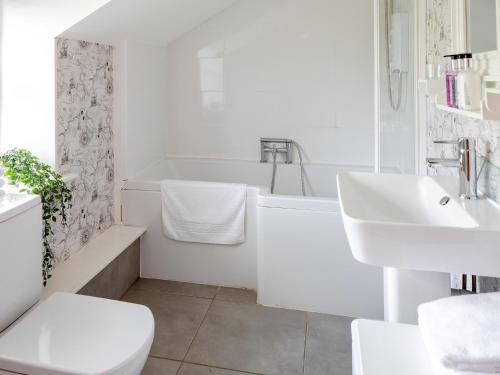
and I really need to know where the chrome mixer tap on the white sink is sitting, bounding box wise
[427,138,478,199]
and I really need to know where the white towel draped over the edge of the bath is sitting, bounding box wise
[161,180,247,245]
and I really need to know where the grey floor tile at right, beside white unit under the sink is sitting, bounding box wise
[304,313,353,375]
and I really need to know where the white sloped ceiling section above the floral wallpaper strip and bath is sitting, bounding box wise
[61,0,238,46]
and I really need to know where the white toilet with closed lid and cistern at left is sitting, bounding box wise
[0,194,154,375]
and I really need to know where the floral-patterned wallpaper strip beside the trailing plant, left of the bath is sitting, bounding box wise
[52,39,114,262]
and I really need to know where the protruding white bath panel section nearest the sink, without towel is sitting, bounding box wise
[257,200,384,319]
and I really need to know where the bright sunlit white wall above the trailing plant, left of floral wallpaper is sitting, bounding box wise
[0,0,109,165]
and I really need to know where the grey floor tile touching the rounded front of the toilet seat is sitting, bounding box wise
[123,289,211,360]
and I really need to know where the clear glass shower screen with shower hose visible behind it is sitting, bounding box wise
[375,0,416,174]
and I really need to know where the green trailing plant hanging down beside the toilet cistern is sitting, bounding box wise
[0,149,72,285]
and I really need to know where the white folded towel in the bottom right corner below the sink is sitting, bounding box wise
[418,293,500,373]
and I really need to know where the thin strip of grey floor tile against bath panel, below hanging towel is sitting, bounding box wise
[132,279,219,298]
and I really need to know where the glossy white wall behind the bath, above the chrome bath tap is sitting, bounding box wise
[167,0,374,164]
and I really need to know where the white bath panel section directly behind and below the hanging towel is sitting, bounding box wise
[122,189,257,289]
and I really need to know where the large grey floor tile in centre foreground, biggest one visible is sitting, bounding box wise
[186,301,306,375]
